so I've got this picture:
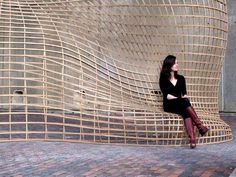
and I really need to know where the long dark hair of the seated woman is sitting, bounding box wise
[160,55,178,79]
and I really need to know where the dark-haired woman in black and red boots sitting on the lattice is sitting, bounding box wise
[159,55,209,148]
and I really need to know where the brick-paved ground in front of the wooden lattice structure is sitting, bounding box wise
[0,117,236,177]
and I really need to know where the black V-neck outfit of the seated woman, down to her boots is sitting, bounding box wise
[159,74,191,118]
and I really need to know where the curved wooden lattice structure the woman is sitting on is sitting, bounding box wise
[0,0,232,145]
